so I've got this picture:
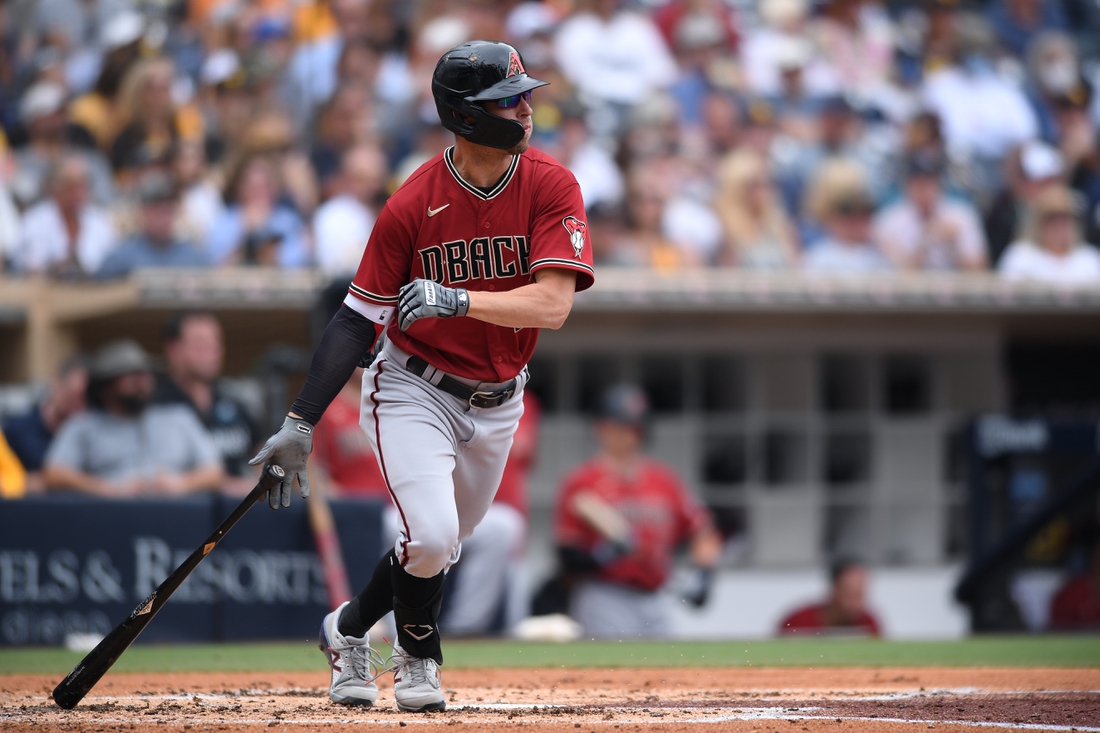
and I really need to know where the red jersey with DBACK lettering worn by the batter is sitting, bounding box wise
[344,147,594,382]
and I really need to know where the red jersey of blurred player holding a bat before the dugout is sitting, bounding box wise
[554,458,711,591]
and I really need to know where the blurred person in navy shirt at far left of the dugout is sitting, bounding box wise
[0,355,88,492]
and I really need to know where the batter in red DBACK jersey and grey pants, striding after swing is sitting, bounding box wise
[252,41,593,711]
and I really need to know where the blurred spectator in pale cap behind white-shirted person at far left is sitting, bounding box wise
[12,81,114,206]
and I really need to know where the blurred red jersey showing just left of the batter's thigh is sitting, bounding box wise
[311,395,389,500]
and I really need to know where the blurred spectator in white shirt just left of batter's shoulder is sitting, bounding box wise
[314,145,386,276]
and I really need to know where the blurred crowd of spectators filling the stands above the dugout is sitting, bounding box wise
[0,0,1100,282]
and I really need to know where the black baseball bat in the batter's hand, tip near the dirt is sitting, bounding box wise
[54,466,286,710]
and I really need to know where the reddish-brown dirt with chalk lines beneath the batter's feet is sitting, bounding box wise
[0,668,1100,733]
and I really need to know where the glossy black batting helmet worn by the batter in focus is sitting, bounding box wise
[431,41,550,150]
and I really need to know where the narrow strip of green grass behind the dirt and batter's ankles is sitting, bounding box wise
[0,636,1100,675]
